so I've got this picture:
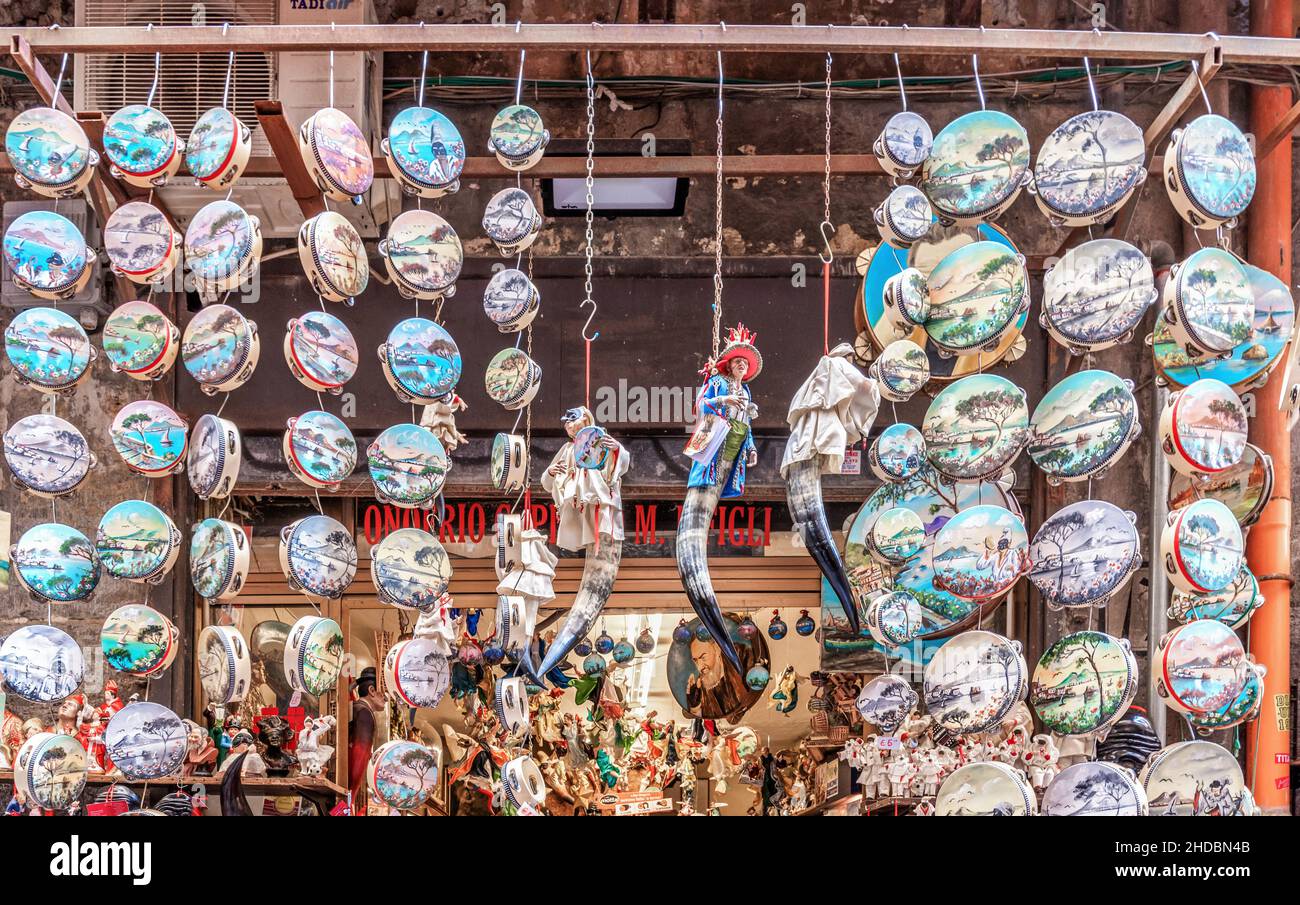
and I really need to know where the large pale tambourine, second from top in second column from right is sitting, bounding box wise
[1040,239,1157,355]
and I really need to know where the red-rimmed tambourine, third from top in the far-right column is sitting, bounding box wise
[1160,377,1249,476]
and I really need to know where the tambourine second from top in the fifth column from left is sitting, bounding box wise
[378,209,465,300]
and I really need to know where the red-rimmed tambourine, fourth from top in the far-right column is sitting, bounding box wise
[1160,499,1245,594]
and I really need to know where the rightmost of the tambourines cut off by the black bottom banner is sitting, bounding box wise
[1138,740,1253,817]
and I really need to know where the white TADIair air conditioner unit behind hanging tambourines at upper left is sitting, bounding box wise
[74,0,402,238]
